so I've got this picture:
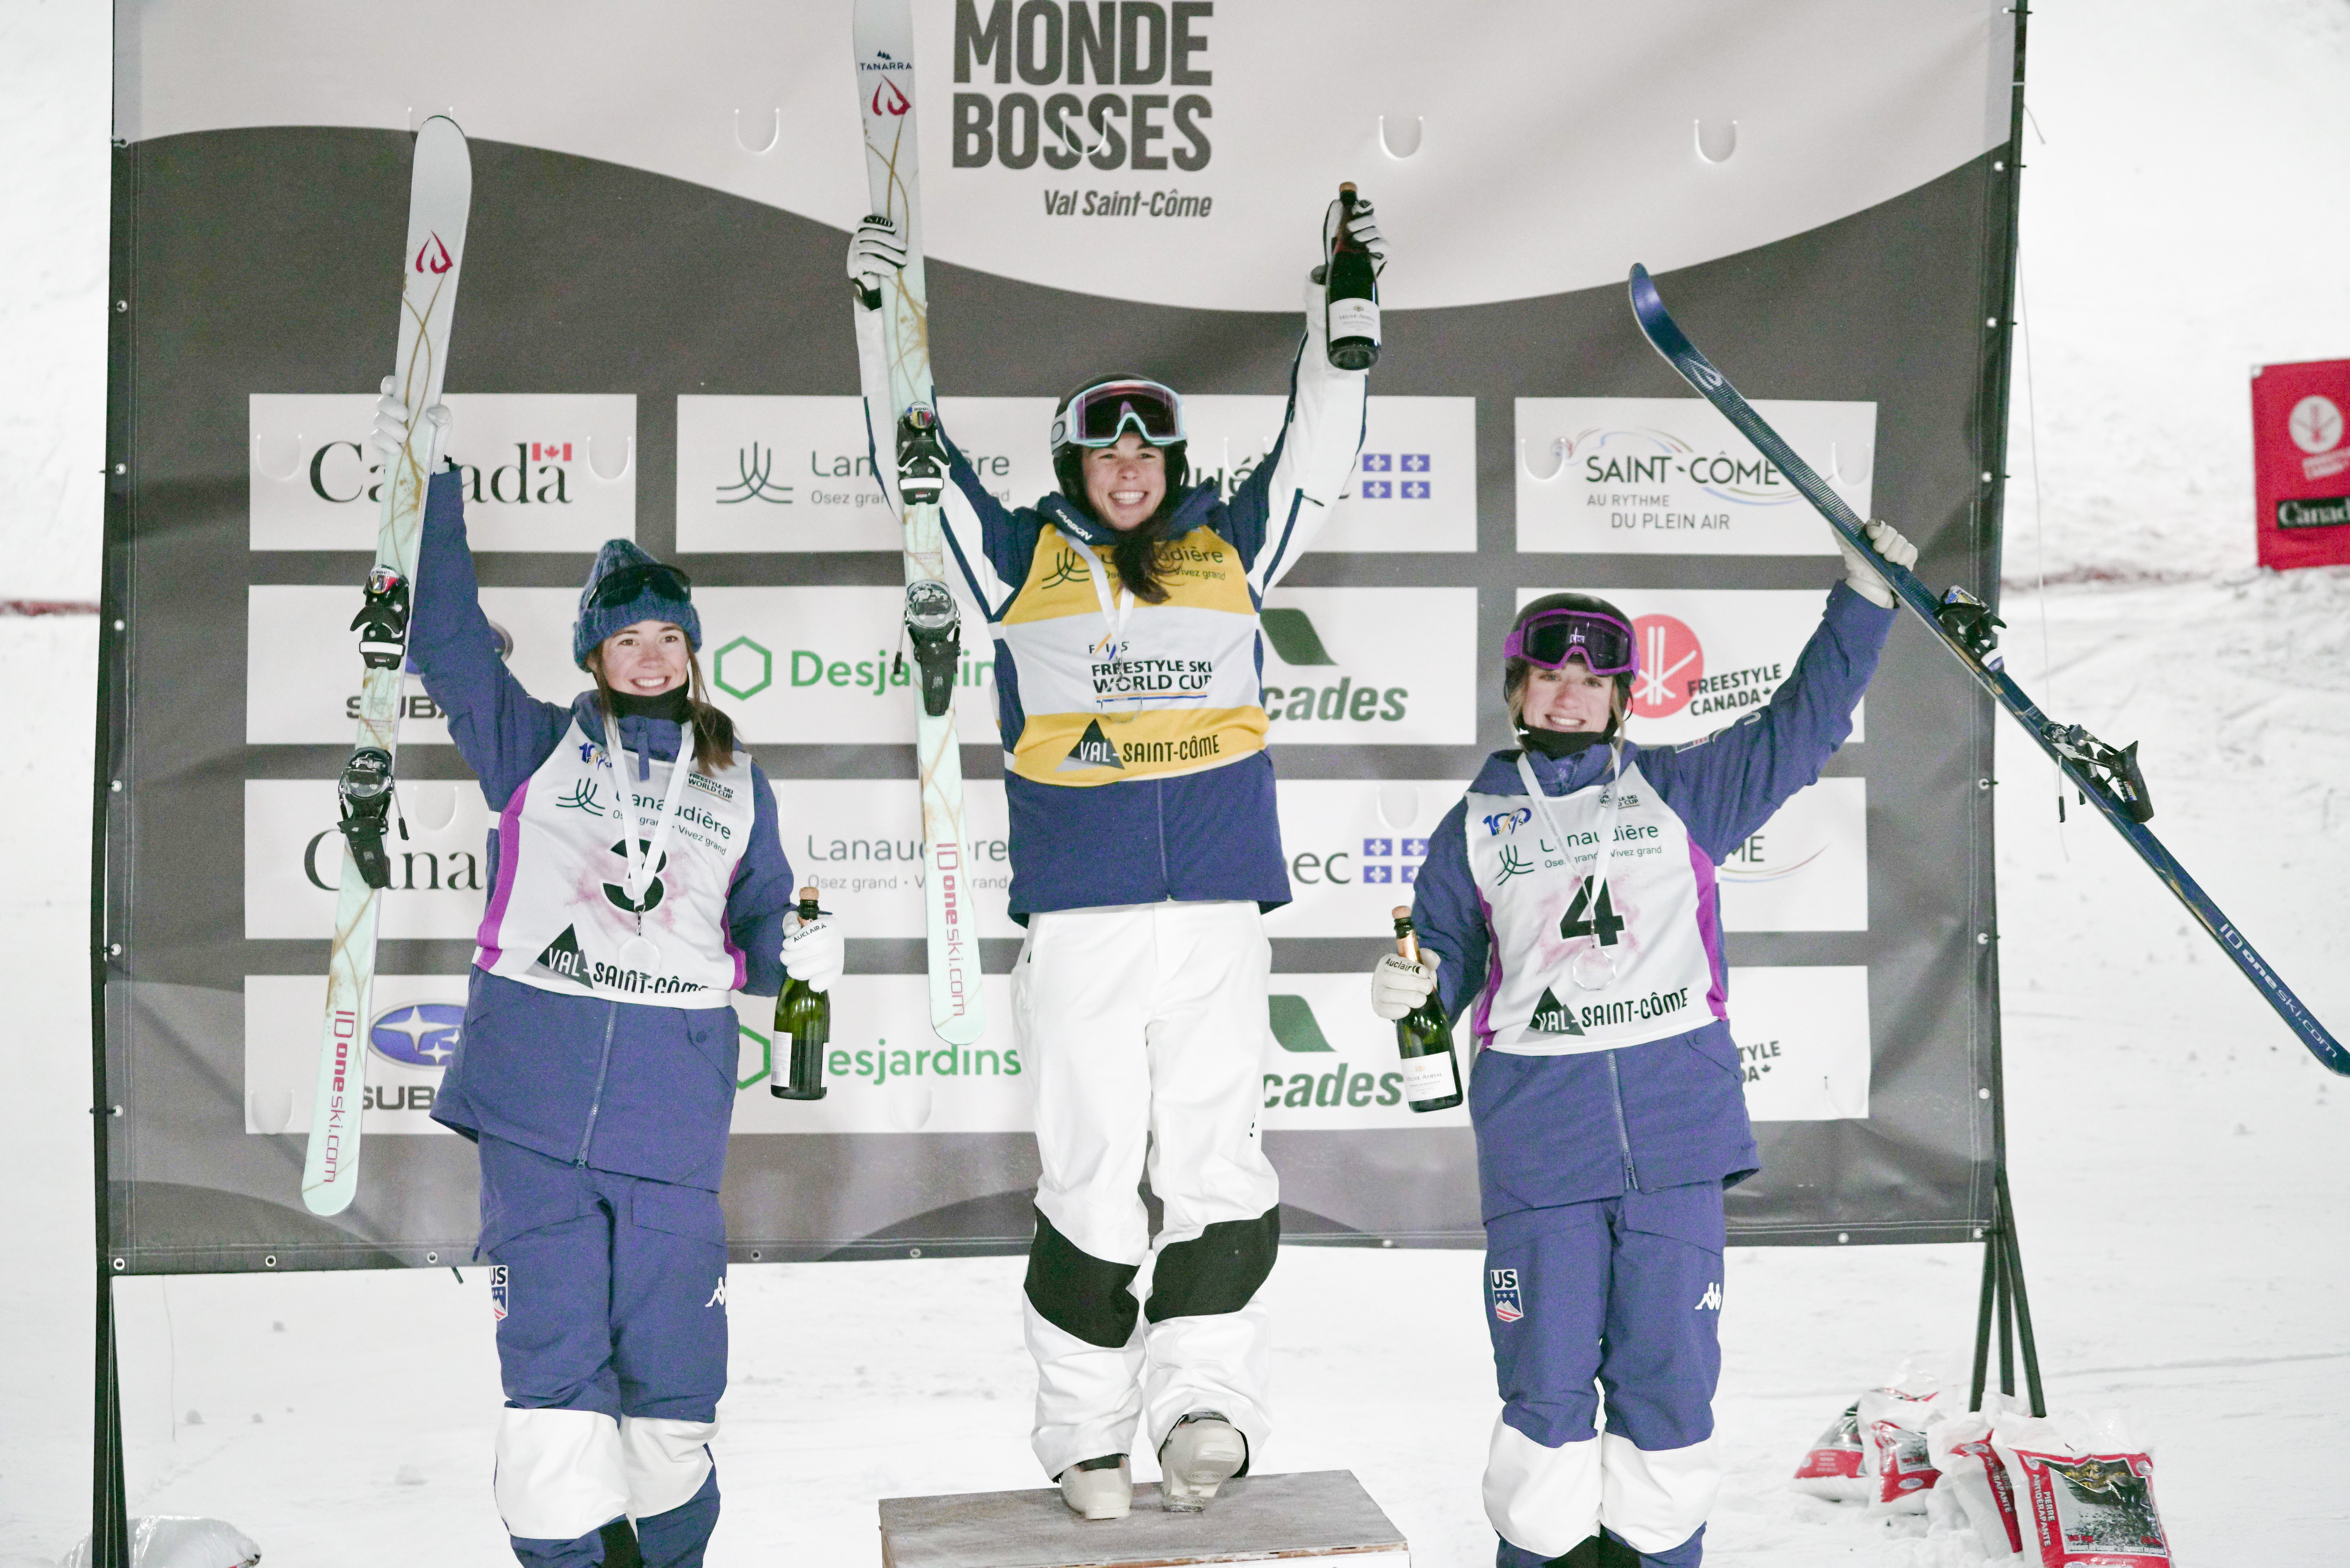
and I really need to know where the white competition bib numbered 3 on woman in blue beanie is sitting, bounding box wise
[472,717,757,1009]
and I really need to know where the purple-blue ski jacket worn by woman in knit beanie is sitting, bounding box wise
[409,470,792,1192]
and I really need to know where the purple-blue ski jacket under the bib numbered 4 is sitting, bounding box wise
[1412,583,1894,1220]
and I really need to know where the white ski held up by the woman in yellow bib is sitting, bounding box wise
[855,0,987,1046]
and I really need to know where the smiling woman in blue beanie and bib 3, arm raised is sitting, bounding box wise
[376,397,841,1568]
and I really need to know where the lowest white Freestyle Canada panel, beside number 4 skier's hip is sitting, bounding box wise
[1730,964,1868,1121]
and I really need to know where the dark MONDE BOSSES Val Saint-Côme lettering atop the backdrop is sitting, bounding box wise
[954,0,1215,192]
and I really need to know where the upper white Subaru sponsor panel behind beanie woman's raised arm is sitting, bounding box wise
[244,585,582,745]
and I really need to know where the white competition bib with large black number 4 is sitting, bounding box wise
[1466,762,1725,1055]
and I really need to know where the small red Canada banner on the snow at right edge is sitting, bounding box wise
[2251,360,2350,571]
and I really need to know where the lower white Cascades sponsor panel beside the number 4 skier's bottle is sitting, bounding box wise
[1257,971,1469,1133]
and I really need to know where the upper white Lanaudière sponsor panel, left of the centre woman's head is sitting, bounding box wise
[677,395,1053,555]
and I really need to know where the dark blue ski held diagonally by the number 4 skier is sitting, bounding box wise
[1631,266,2350,1077]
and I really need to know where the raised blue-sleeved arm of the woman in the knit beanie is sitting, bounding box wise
[409,468,571,811]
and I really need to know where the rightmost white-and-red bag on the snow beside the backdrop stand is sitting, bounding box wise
[1990,1413,2171,1568]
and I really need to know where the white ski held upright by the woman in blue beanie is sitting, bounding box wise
[301,115,472,1213]
